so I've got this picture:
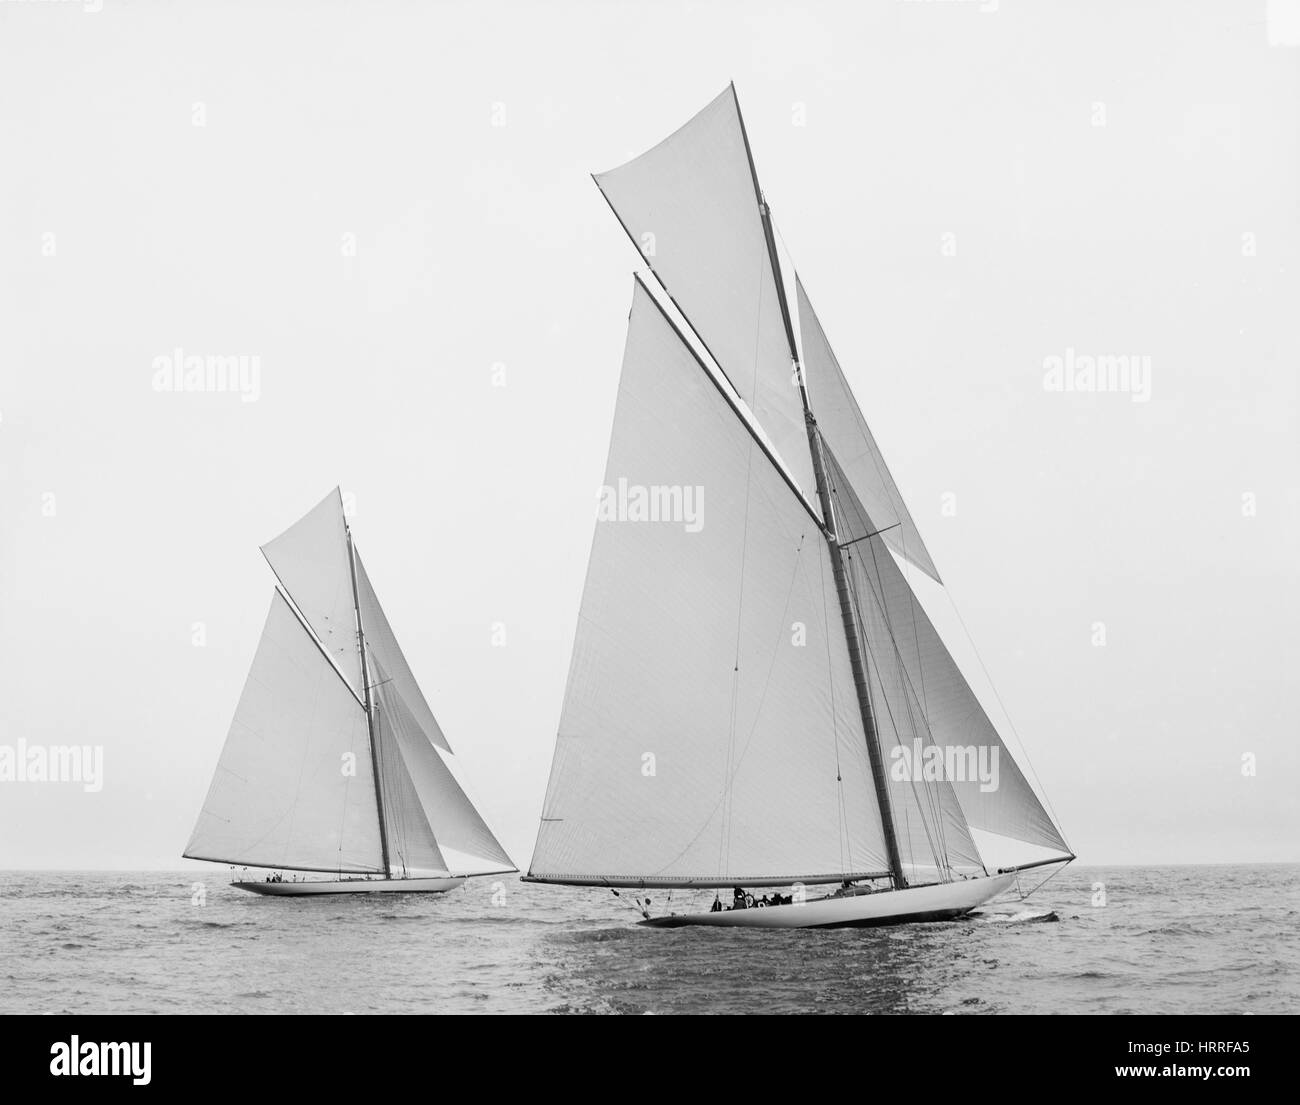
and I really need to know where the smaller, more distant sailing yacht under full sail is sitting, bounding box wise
[185,488,516,897]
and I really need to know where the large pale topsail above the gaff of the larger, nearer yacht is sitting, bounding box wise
[595,86,815,501]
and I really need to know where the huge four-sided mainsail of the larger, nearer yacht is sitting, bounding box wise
[530,281,888,885]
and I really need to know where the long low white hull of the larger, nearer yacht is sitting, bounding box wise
[641,874,1015,928]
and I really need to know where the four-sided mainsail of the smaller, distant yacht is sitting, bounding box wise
[185,592,384,872]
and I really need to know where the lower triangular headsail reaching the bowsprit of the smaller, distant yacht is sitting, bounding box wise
[374,664,515,874]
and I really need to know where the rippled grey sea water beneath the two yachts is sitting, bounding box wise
[0,865,1300,1014]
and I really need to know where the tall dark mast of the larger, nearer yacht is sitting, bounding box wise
[732,101,907,889]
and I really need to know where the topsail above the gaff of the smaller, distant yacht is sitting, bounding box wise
[261,488,364,696]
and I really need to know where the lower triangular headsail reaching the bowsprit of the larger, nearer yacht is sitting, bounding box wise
[823,442,1069,858]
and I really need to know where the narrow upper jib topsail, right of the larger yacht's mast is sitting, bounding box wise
[794,277,939,581]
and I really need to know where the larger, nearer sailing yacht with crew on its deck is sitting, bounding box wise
[525,87,1074,928]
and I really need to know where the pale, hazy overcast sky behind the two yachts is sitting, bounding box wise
[0,0,1300,868]
